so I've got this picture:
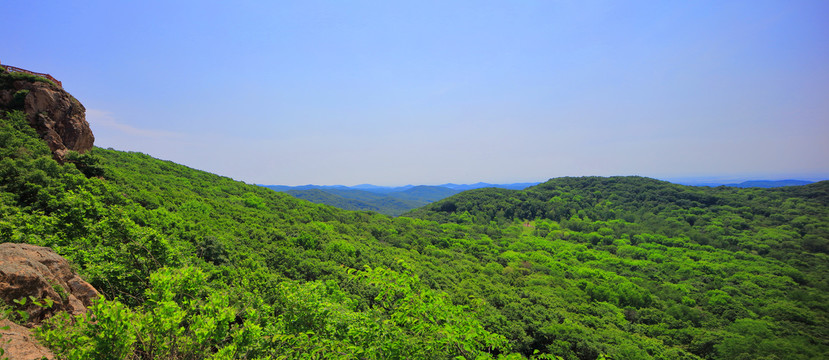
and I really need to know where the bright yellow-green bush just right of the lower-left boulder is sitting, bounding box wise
[37,268,235,359]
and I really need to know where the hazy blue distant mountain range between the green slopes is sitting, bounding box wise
[260,182,539,216]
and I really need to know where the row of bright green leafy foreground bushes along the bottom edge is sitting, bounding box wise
[37,267,506,359]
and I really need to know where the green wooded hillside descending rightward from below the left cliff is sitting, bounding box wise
[0,112,509,359]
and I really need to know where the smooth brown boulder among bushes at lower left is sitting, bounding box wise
[0,243,100,325]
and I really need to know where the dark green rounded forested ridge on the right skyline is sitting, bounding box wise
[412,176,829,225]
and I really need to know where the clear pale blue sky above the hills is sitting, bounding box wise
[0,0,829,185]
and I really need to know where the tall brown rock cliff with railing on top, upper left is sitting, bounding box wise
[0,68,95,162]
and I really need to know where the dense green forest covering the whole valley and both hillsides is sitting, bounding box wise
[0,108,829,359]
